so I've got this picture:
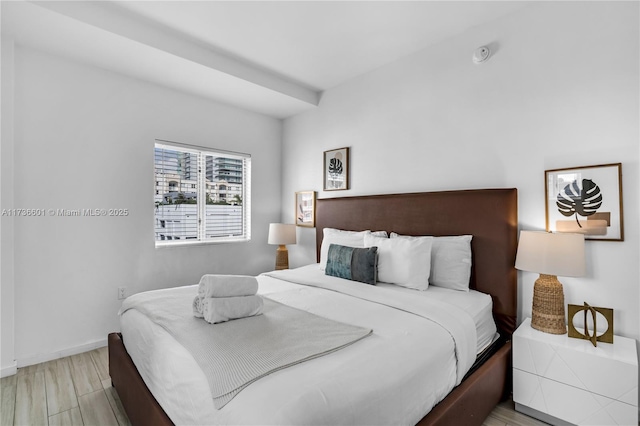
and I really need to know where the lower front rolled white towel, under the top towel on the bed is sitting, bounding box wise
[202,295,264,324]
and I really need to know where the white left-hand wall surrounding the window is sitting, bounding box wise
[2,47,282,368]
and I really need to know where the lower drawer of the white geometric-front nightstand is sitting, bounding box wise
[513,368,638,425]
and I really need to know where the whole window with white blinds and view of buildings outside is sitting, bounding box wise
[154,140,251,247]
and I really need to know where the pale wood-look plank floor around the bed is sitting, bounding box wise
[0,347,545,426]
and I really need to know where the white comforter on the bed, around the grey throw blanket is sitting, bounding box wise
[121,265,488,425]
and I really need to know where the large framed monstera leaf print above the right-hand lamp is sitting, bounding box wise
[544,163,624,241]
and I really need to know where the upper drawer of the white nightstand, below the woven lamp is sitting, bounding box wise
[513,327,638,406]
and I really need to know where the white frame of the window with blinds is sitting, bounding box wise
[153,139,251,248]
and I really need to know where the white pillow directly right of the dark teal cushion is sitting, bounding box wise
[364,234,433,290]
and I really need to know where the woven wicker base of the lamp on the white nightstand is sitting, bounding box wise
[531,274,567,334]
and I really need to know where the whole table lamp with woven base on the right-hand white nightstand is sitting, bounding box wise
[516,231,585,334]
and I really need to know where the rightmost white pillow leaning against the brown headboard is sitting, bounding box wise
[391,232,473,291]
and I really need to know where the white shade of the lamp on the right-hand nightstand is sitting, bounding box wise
[516,231,586,277]
